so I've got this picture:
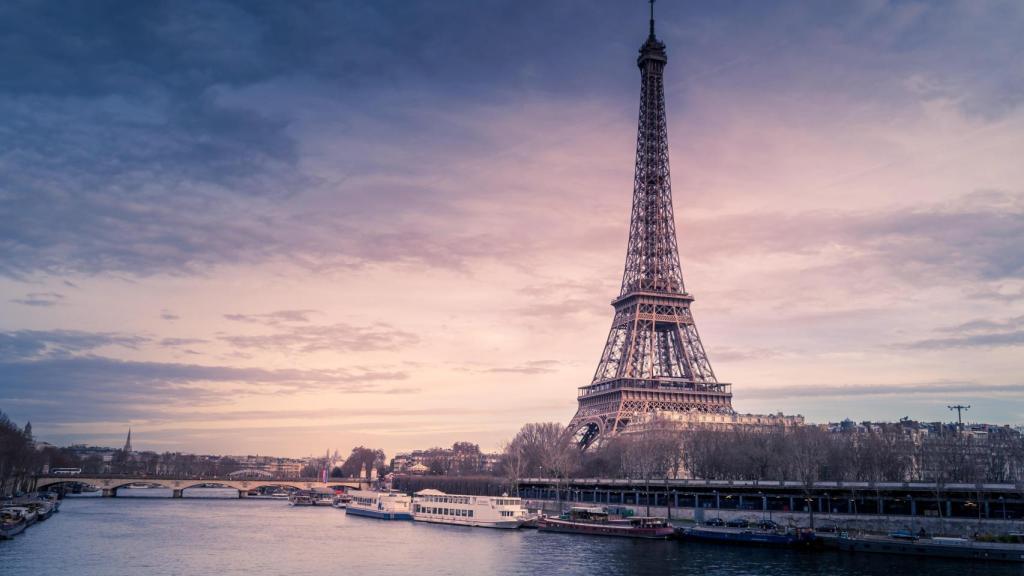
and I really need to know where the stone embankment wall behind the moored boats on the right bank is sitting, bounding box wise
[525,500,1024,536]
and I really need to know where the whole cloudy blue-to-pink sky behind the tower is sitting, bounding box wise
[0,0,1024,456]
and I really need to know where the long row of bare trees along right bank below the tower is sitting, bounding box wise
[503,421,1024,483]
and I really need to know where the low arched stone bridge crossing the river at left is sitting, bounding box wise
[36,475,370,498]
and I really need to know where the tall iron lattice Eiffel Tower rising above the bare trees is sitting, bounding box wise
[568,0,733,449]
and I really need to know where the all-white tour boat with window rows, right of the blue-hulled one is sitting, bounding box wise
[413,490,530,529]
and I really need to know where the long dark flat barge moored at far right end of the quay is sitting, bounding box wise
[836,532,1024,563]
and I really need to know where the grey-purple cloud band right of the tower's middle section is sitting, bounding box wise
[686,193,1024,284]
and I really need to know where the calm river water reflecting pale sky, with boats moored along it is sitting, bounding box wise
[0,490,1024,576]
